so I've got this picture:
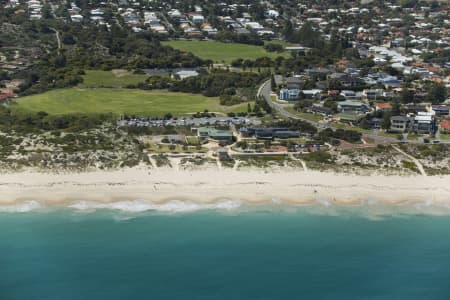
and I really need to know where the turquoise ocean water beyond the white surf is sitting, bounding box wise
[0,208,450,300]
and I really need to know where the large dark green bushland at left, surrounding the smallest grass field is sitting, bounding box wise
[2,14,207,94]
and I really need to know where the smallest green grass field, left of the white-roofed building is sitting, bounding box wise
[80,70,148,88]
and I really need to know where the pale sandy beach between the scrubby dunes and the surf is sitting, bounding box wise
[0,168,450,211]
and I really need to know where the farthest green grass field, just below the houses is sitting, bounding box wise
[163,41,288,64]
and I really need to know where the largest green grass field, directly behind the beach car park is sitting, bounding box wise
[13,88,253,116]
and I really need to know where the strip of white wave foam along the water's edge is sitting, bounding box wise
[0,198,450,219]
